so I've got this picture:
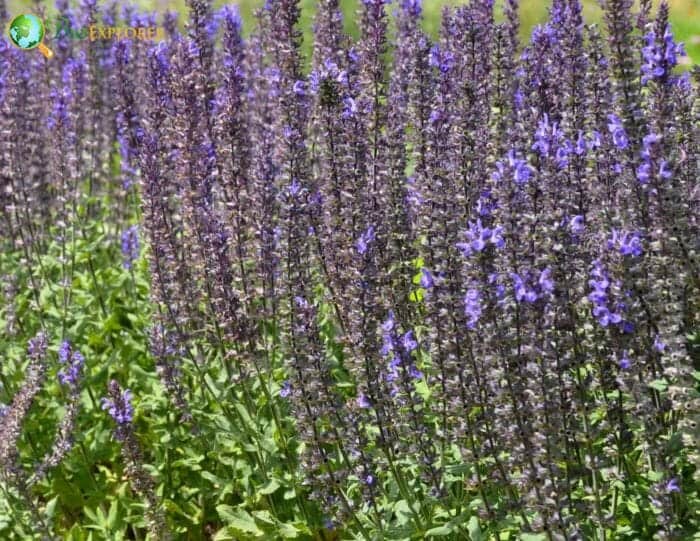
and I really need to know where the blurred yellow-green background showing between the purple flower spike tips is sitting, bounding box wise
[9,0,700,64]
